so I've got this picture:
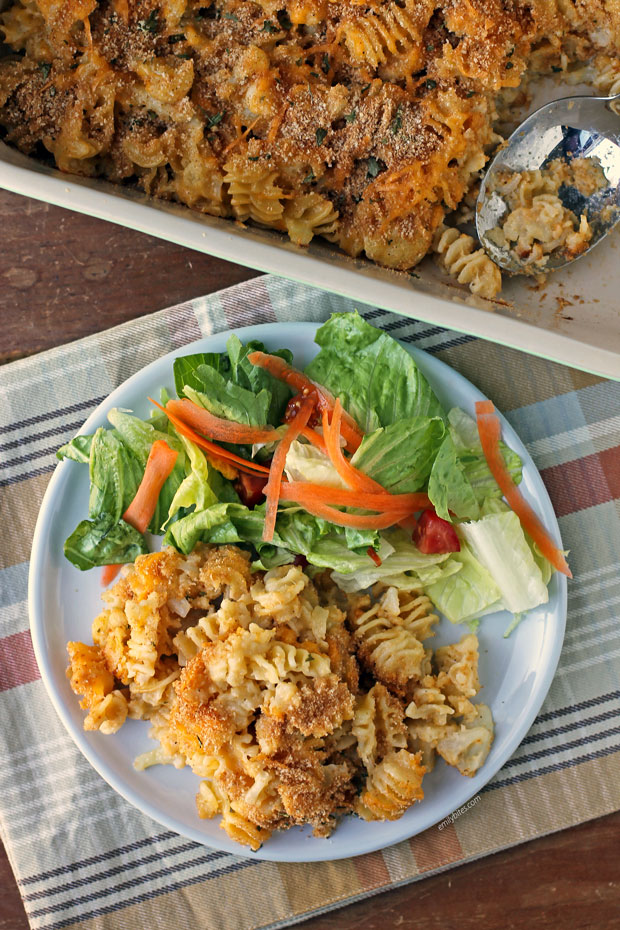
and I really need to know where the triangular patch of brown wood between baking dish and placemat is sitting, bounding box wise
[0,190,257,362]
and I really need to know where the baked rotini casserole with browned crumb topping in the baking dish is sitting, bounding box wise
[0,0,620,298]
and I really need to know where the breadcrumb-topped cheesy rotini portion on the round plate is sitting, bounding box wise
[68,545,493,849]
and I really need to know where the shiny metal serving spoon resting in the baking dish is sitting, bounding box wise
[476,94,620,274]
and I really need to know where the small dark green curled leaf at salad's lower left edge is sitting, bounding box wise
[64,513,148,571]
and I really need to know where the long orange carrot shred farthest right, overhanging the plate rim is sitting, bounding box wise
[476,400,573,578]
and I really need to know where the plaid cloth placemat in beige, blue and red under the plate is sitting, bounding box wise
[0,277,620,930]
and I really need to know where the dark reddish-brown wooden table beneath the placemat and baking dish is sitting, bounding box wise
[0,191,620,930]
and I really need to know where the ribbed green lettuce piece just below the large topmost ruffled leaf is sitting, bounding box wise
[352,417,445,494]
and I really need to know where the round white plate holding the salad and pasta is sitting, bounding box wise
[29,323,566,862]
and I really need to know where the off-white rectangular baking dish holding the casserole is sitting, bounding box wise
[0,82,620,380]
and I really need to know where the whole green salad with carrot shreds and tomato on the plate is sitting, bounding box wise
[57,313,568,623]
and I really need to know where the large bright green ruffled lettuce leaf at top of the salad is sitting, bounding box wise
[306,311,443,433]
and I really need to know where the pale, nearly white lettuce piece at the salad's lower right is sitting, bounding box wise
[458,510,549,614]
